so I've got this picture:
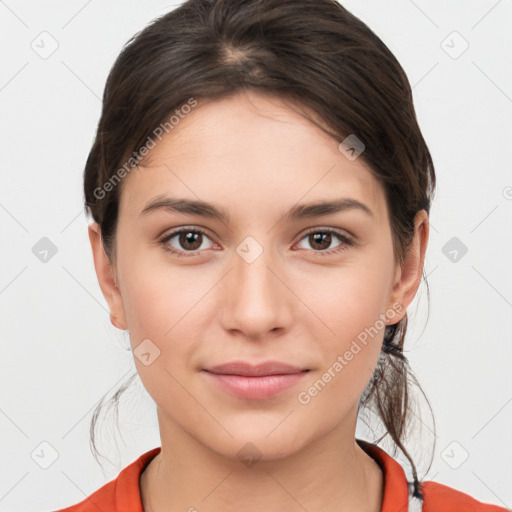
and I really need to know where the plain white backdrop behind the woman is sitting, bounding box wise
[0,0,512,512]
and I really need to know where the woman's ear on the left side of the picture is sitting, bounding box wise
[89,222,126,330]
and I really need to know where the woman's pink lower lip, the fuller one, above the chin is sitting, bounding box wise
[203,370,308,400]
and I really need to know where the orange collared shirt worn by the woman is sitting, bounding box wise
[56,439,507,512]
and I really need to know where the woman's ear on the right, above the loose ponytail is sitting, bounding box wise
[390,210,429,323]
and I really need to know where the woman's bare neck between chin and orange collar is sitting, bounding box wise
[140,414,383,512]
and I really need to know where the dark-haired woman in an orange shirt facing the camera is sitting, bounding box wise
[57,0,504,512]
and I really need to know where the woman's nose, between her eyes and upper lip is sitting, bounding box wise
[220,241,293,340]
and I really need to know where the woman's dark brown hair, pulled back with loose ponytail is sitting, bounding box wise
[84,0,435,497]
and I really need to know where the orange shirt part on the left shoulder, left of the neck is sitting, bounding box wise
[55,447,161,512]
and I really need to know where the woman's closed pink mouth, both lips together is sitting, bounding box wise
[202,361,309,400]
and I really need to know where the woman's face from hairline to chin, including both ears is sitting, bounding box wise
[90,92,427,459]
